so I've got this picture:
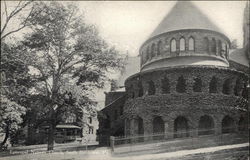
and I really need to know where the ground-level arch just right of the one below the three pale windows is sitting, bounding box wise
[198,115,214,135]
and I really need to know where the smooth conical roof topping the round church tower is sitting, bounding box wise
[150,1,223,38]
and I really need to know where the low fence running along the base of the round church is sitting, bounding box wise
[110,128,248,153]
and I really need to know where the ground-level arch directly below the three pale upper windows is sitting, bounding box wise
[174,116,189,138]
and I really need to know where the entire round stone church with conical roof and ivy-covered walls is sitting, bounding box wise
[98,1,249,145]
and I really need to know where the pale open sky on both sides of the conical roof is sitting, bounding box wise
[77,1,246,56]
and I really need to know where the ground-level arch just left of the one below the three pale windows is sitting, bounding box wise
[153,116,165,140]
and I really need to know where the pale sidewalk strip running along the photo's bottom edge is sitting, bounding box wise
[0,143,249,160]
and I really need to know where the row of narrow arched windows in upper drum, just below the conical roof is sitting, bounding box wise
[142,36,229,64]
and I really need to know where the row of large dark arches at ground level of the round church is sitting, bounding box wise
[132,114,248,137]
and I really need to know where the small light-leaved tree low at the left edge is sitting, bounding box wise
[0,96,26,146]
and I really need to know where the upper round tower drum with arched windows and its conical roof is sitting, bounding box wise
[140,1,230,71]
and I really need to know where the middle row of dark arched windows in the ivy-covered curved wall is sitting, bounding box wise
[129,76,245,98]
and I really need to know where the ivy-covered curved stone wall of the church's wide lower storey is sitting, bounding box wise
[124,66,247,138]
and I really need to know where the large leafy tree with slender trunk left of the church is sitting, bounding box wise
[23,2,123,150]
